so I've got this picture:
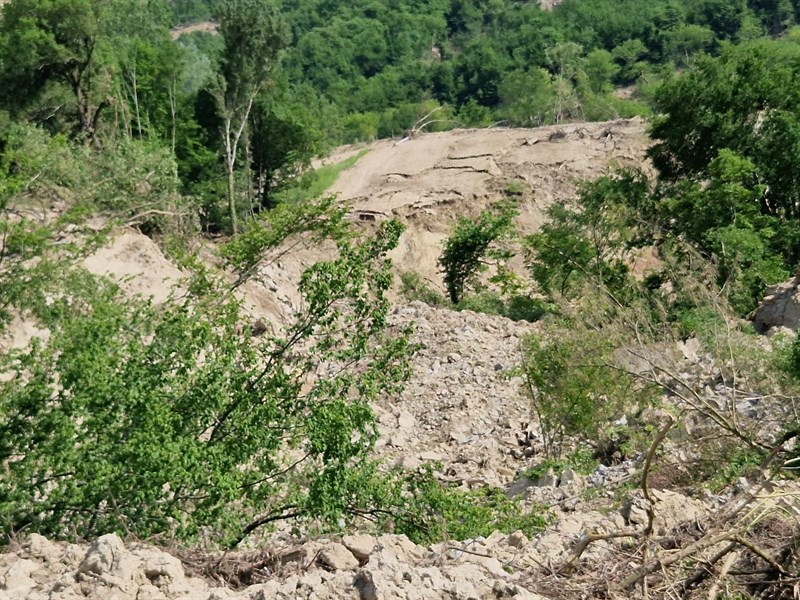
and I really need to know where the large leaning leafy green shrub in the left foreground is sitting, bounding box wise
[0,217,412,545]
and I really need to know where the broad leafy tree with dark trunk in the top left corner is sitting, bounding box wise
[0,0,174,146]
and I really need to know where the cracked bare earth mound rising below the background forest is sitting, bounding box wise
[326,119,649,290]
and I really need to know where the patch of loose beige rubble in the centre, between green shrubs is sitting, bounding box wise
[376,302,534,487]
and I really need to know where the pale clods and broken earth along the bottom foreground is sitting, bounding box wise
[0,492,704,600]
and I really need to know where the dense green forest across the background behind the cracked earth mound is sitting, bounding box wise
[0,0,800,232]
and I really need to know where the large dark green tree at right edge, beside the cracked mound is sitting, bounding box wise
[649,40,800,264]
